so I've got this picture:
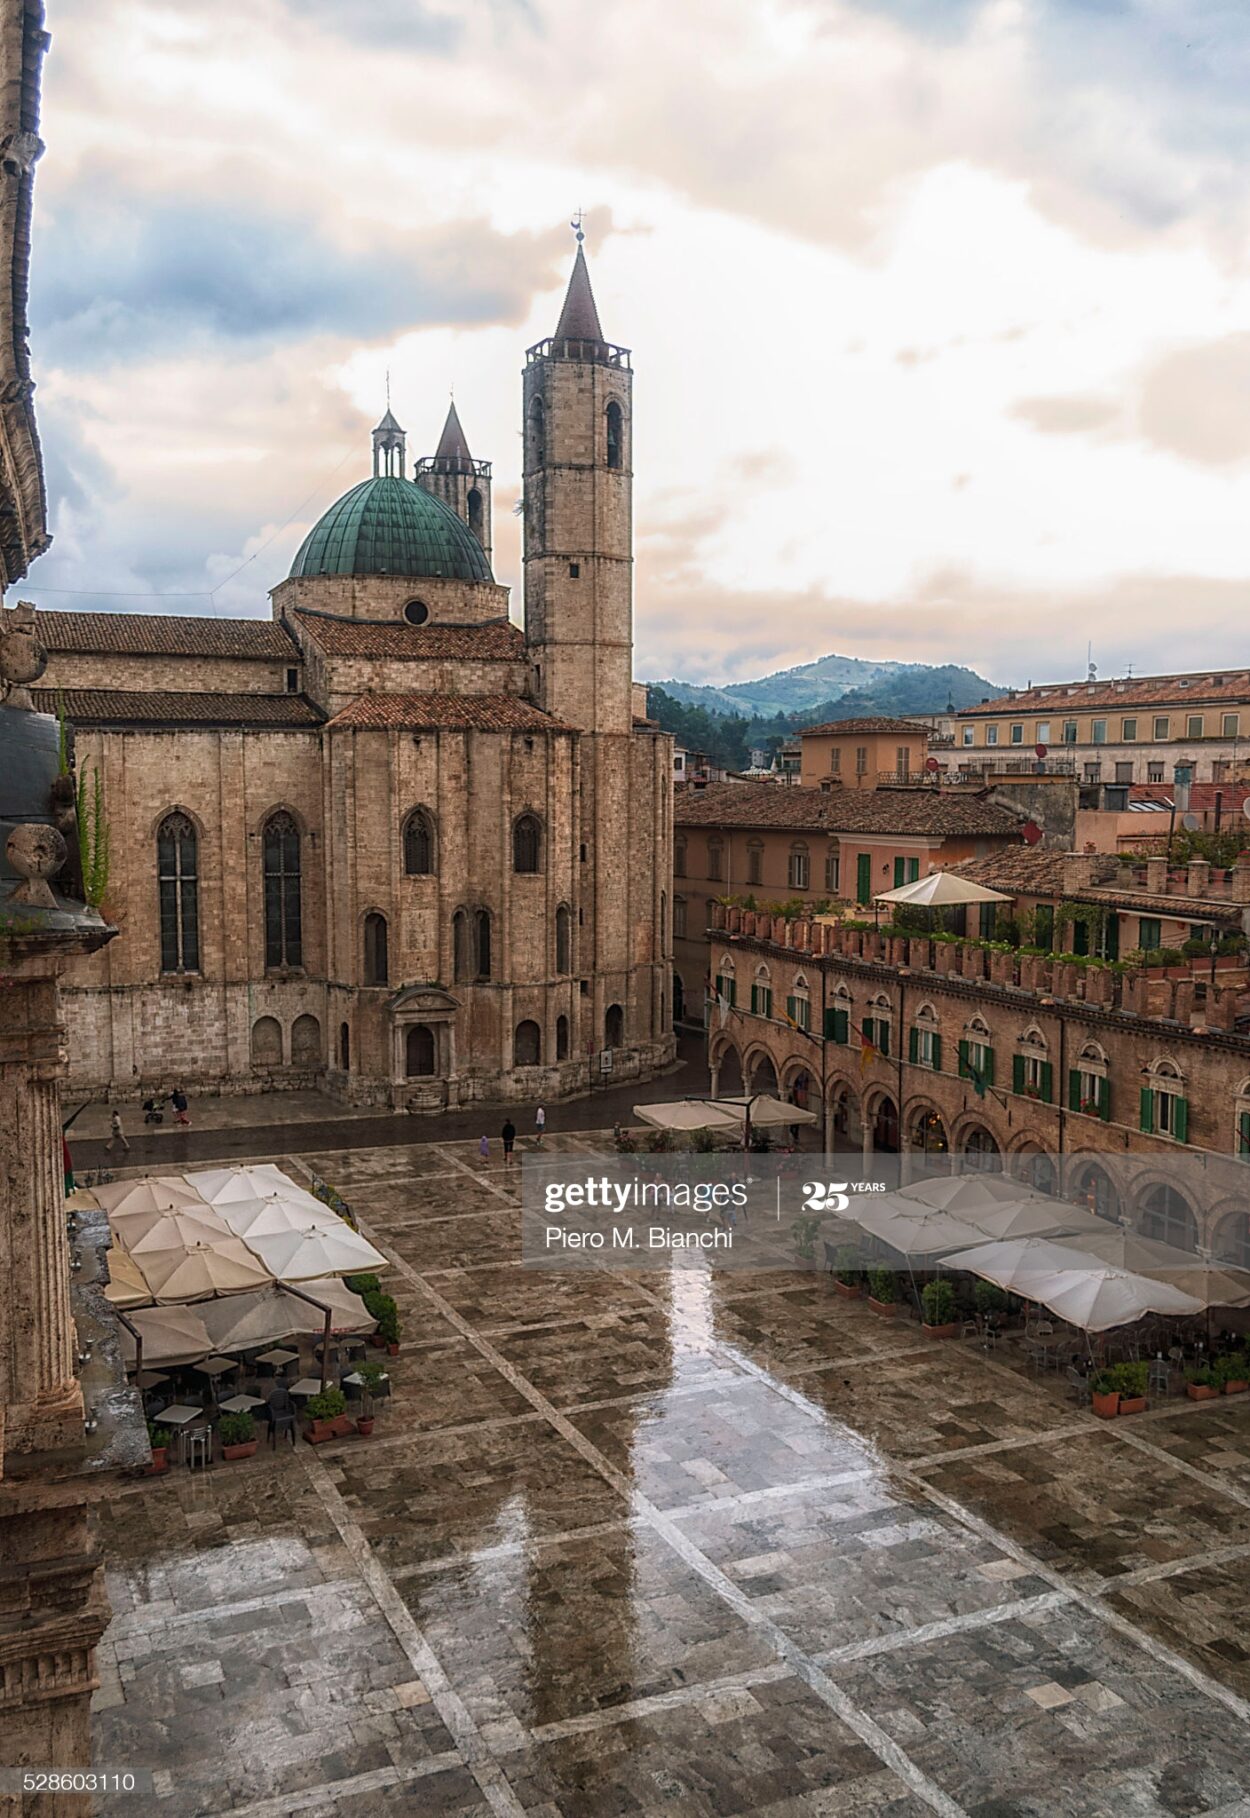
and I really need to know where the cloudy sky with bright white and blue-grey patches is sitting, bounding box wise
[22,0,1250,682]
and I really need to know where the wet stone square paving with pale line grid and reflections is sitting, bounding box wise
[96,1125,1250,1818]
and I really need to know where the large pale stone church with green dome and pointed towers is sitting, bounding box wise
[36,244,674,1111]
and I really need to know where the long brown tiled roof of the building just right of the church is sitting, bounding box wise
[672,784,1019,840]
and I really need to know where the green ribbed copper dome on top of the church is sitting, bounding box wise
[291,476,494,582]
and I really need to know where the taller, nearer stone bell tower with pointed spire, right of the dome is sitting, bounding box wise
[523,238,634,736]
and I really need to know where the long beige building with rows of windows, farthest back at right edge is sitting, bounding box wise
[948,669,1250,784]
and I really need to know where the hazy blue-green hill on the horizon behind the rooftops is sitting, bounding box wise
[650,654,1003,720]
